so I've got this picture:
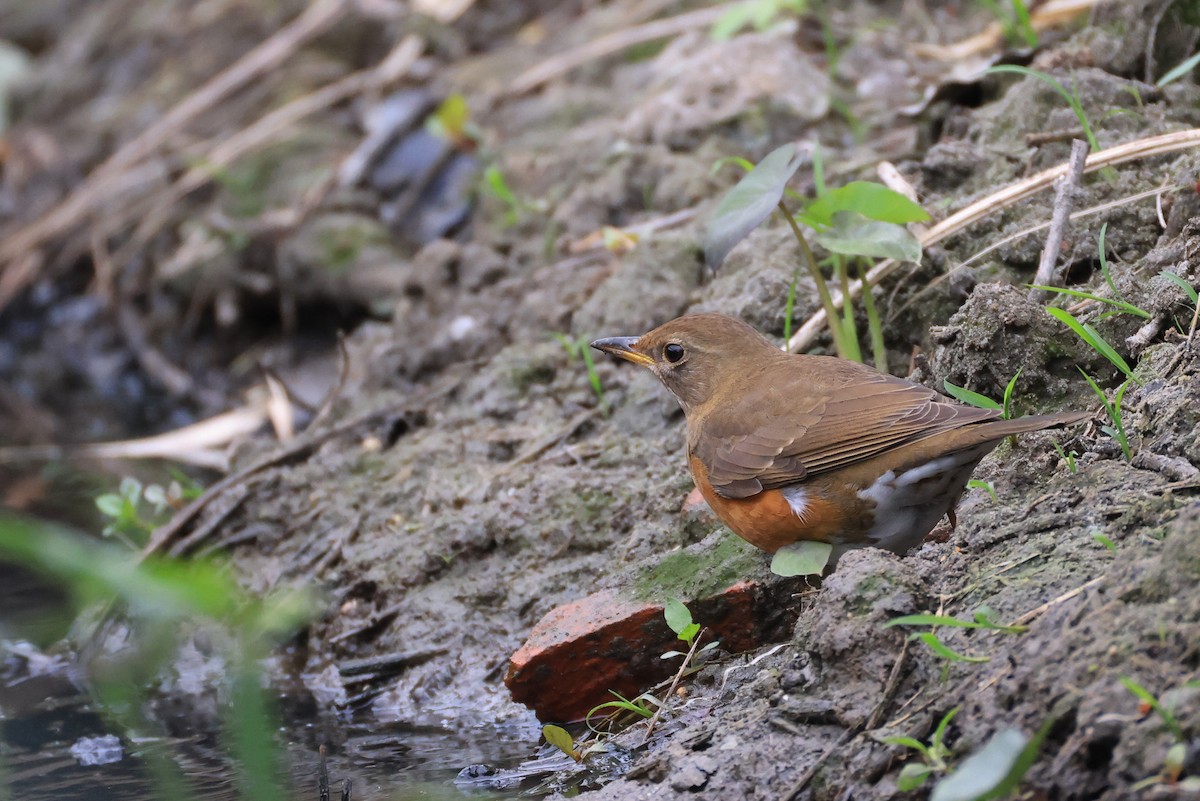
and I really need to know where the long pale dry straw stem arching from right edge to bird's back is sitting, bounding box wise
[787,128,1200,353]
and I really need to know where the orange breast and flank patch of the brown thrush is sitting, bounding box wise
[689,457,845,553]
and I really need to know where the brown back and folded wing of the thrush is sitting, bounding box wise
[690,360,1000,498]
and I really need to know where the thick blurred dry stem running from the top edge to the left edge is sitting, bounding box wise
[0,0,347,309]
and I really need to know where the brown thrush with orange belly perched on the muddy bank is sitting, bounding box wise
[592,314,1090,558]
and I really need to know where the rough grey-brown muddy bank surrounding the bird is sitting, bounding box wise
[0,0,1200,800]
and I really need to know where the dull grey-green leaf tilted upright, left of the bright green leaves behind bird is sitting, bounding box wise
[704,143,808,270]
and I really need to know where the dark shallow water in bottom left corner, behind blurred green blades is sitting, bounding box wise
[0,566,538,801]
